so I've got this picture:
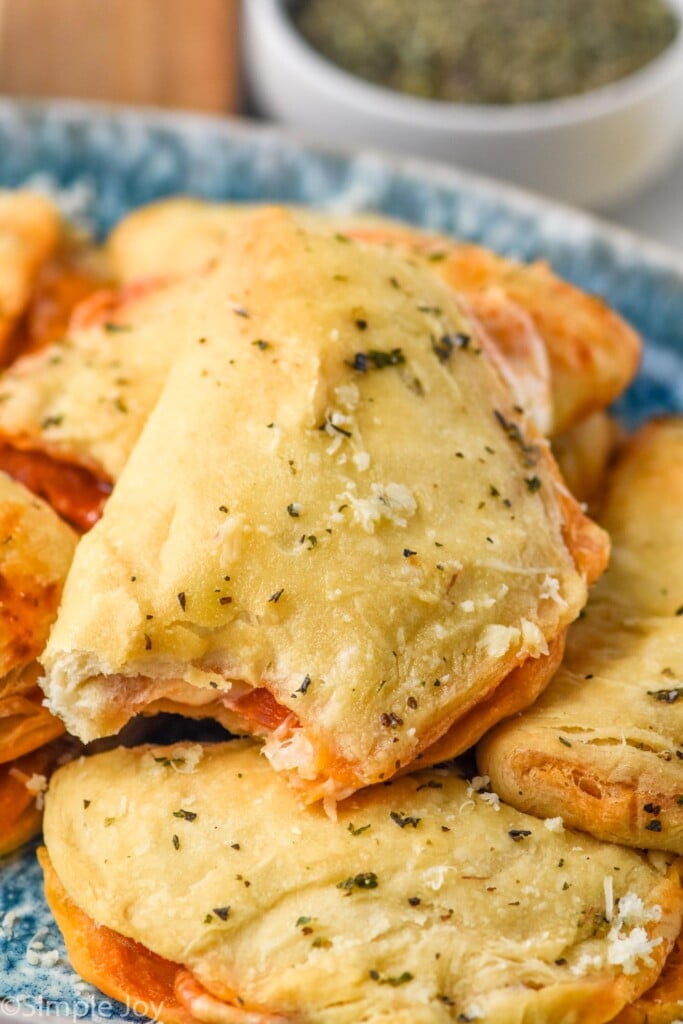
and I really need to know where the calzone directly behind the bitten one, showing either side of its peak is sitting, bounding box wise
[108,198,641,434]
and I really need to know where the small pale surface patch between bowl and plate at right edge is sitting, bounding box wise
[597,142,683,251]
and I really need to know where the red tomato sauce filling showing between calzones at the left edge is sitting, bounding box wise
[0,443,112,530]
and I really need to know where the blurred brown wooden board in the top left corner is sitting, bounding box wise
[0,0,239,113]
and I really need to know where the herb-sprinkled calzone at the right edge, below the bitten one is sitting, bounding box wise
[477,418,683,853]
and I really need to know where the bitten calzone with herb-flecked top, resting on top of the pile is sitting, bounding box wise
[43,210,606,800]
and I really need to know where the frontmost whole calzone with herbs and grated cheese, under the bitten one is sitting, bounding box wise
[43,740,683,1024]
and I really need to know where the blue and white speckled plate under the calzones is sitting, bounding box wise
[0,101,683,1020]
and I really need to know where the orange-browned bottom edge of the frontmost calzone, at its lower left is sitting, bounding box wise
[38,847,282,1024]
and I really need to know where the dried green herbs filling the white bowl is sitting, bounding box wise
[291,0,679,105]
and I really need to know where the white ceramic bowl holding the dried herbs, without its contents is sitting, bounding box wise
[243,0,683,206]
